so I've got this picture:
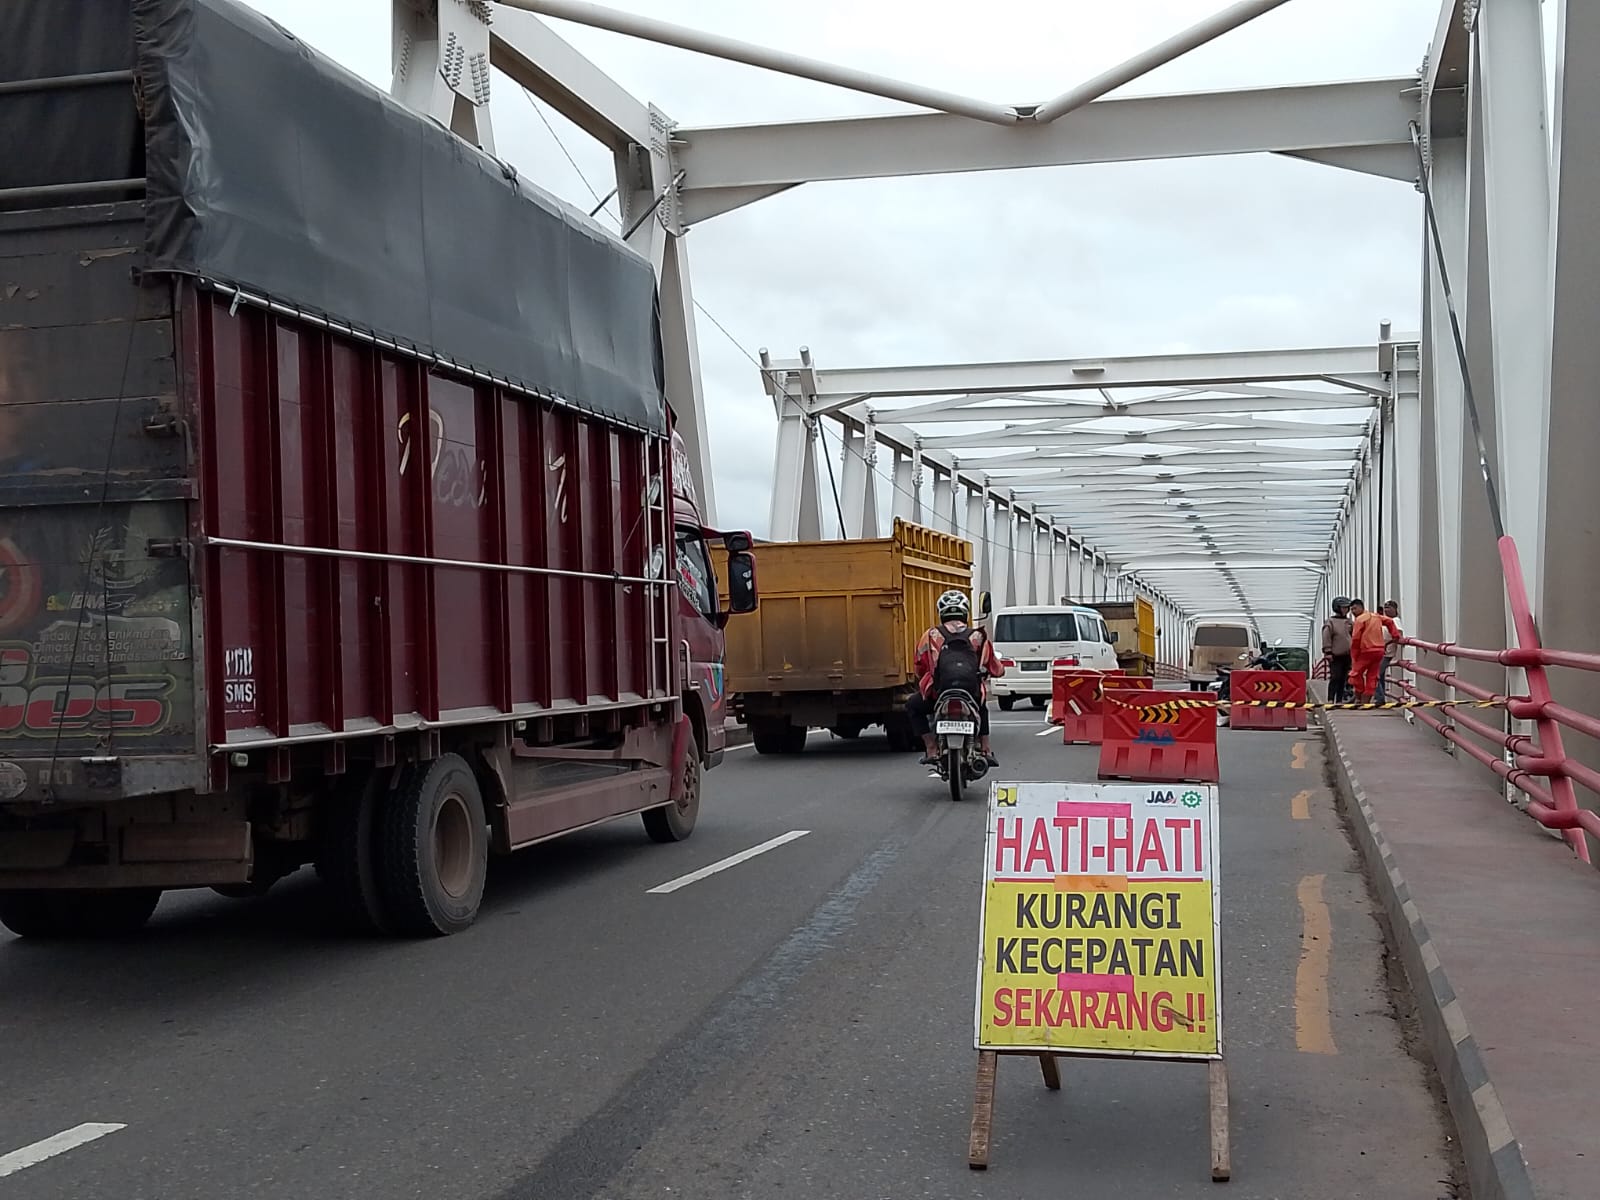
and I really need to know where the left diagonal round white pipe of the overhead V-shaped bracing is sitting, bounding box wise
[499,0,1018,125]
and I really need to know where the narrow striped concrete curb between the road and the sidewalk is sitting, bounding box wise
[1322,722,1536,1200]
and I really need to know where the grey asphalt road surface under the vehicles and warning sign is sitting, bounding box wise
[0,712,1454,1200]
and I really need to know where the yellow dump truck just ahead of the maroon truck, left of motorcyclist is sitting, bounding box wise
[718,520,973,754]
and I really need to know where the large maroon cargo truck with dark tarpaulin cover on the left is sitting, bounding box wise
[0,0,755,936]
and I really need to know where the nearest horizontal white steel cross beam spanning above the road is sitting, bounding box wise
[668,77,1418,221]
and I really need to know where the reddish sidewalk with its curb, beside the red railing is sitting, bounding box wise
[1325,712,1600,1200]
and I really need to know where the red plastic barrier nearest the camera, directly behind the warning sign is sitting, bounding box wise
[1099,688,1221,784]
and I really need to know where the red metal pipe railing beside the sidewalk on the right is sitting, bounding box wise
[1395,538,1600,862]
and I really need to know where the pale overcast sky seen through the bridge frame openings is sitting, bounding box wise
[233,0,1536,592]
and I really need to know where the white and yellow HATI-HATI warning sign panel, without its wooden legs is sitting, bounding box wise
[974,782,1222,1059]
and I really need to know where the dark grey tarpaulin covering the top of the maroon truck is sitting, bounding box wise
[133,0,666,432]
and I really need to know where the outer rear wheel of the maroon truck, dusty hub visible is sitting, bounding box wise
[378,754,490,938]
